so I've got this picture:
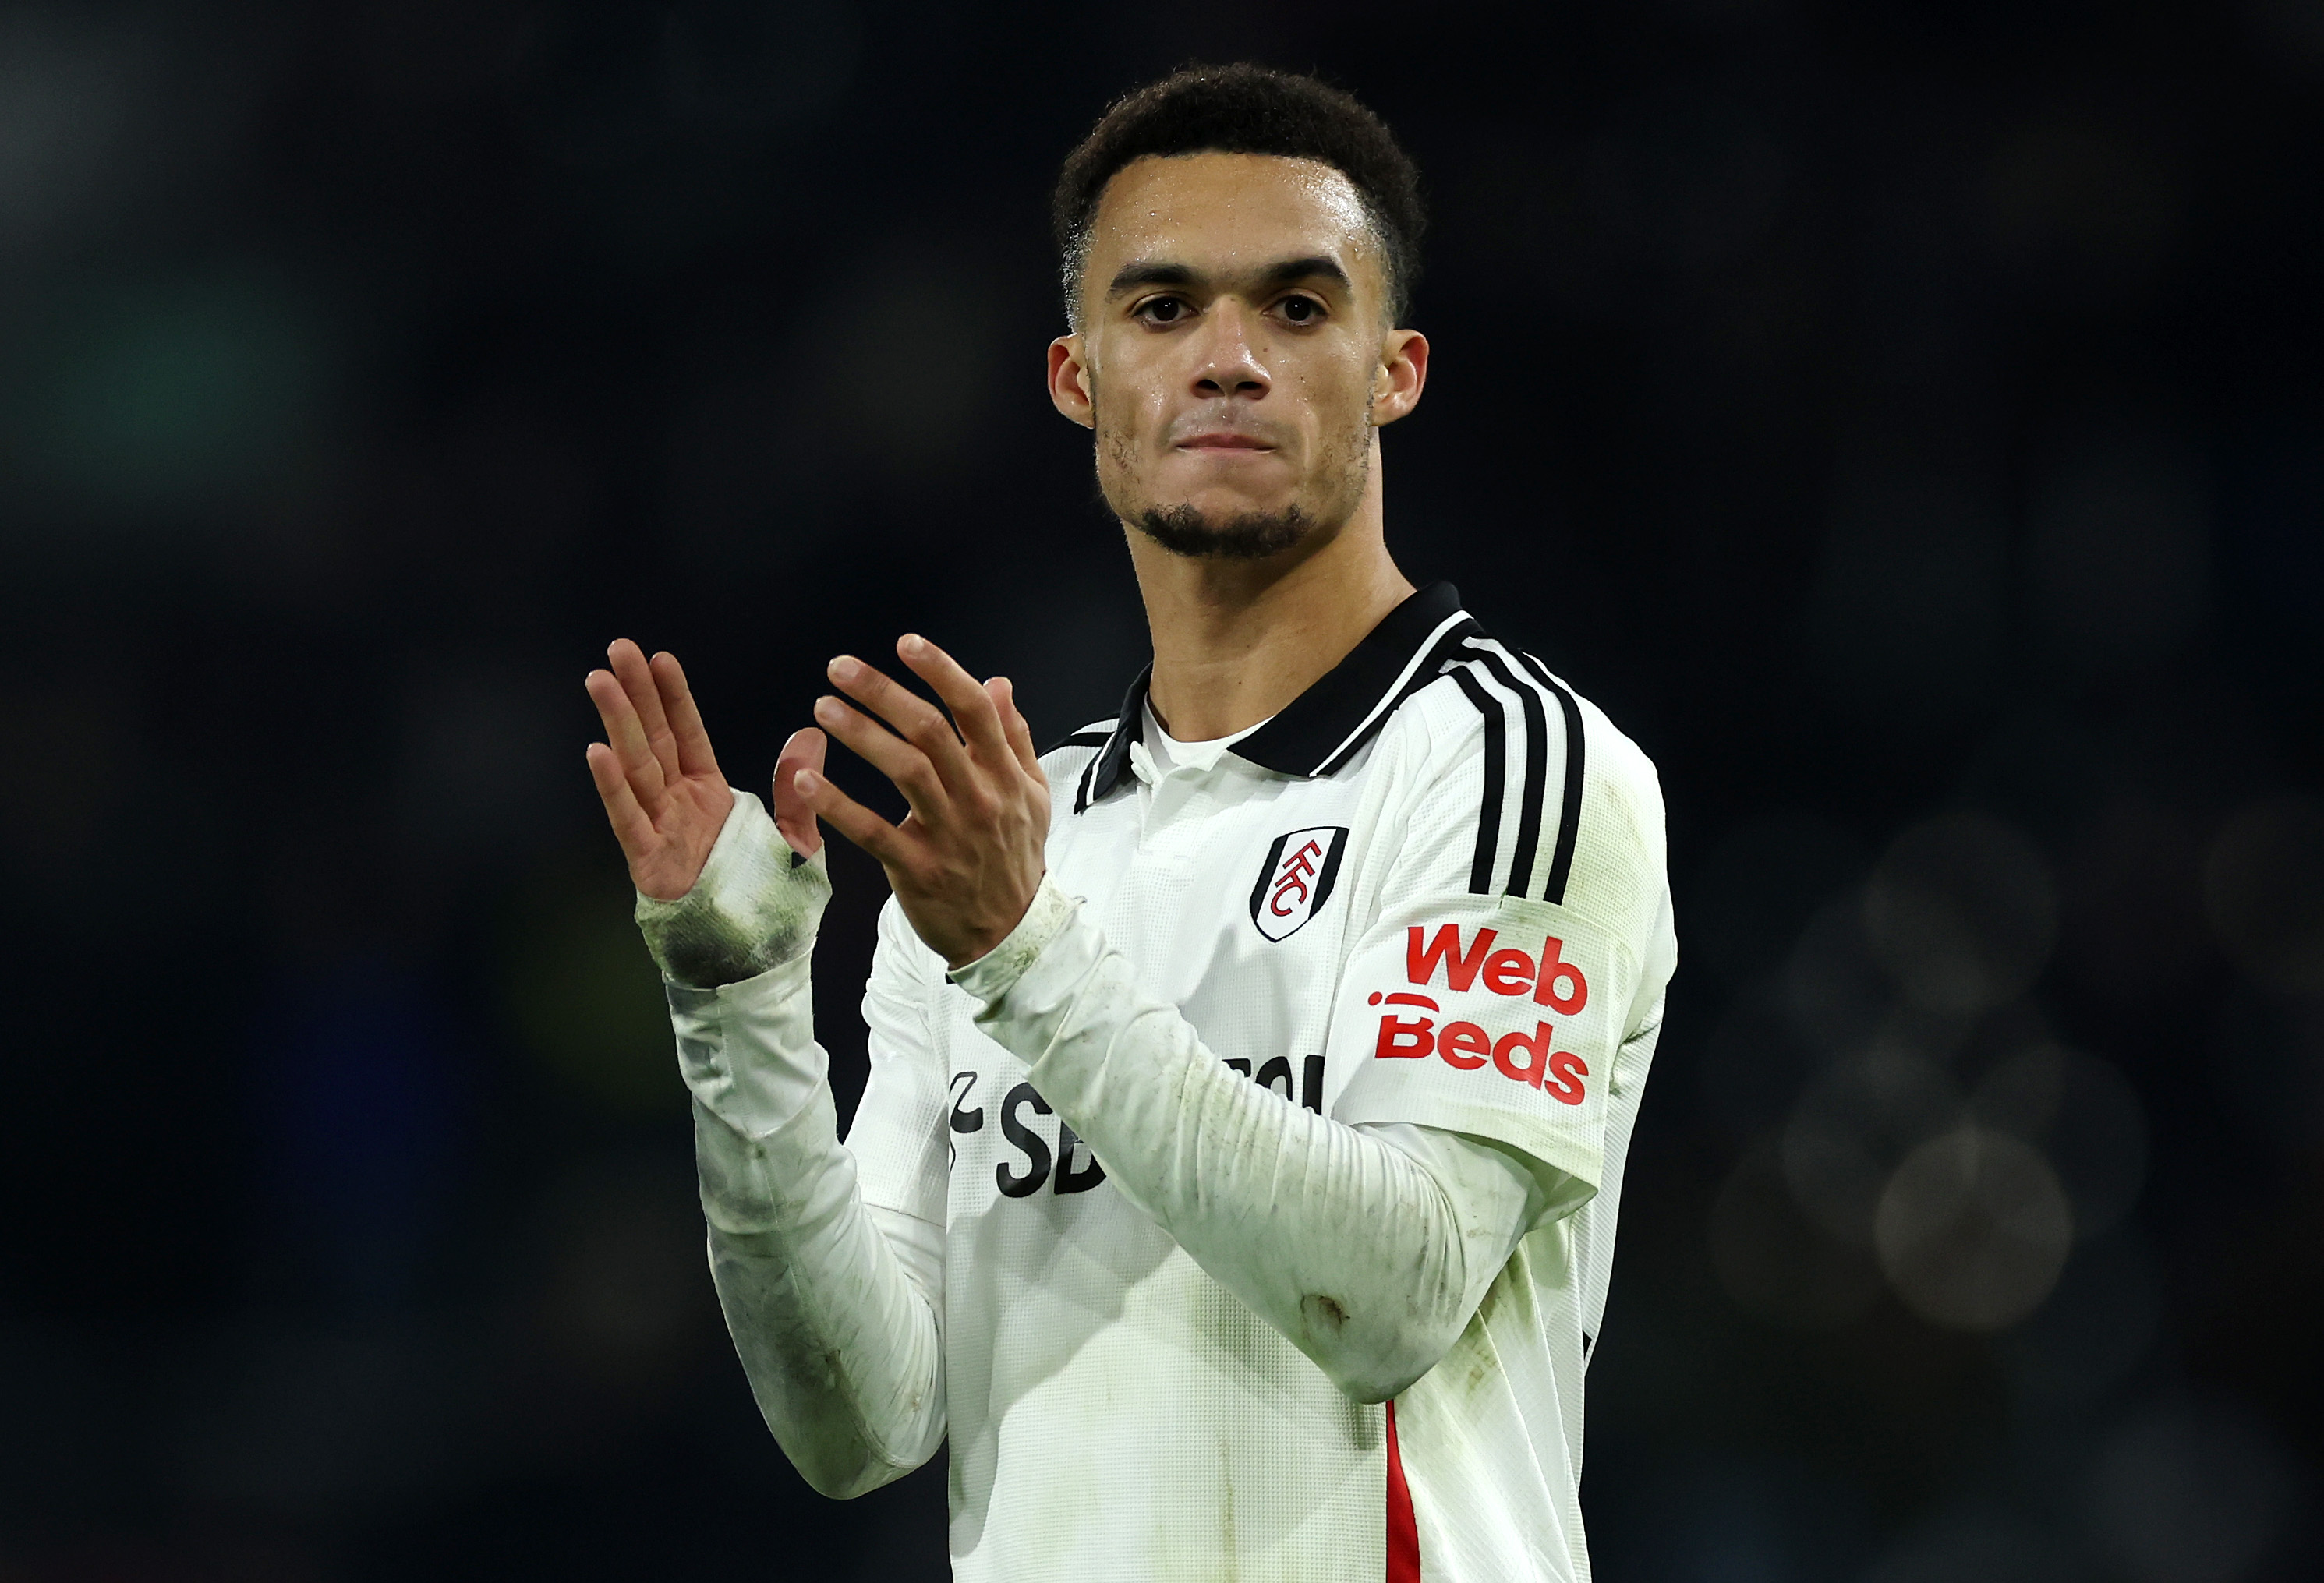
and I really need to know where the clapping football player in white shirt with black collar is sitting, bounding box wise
[588,65,1675,1583]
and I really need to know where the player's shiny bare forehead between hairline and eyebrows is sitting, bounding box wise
[1090,154,1378,277]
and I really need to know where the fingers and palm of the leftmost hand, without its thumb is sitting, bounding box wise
[588,639,734,902]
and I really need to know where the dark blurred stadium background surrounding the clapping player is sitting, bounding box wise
[0,0,2324,1583]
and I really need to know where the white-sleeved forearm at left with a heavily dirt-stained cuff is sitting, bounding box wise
[639,795,943,1495]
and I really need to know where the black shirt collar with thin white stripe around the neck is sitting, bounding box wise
[1074,584,1478,814]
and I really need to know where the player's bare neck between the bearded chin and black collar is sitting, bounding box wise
[1130,437,1413,741]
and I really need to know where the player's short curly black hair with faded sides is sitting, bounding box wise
[1050,63,1427,326]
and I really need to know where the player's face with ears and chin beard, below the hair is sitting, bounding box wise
[1050,154,1427,556]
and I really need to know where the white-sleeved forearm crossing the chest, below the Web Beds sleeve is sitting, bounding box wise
[955,888,1540,1399]
